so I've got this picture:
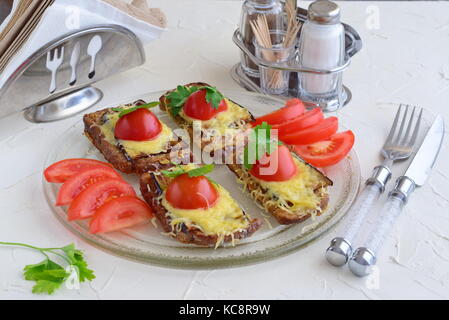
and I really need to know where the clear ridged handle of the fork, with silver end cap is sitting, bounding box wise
[326,166,391,267]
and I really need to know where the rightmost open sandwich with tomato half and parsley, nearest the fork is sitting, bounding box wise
[227,123,332,224]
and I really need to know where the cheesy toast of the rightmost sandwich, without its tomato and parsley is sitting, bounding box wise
[227,152,333,225]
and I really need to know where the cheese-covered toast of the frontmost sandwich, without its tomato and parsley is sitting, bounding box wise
[140,164,262,248]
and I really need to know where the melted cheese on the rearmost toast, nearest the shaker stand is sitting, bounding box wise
[179,98,250,135]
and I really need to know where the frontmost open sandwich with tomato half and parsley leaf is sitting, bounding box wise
[140,164,262,247]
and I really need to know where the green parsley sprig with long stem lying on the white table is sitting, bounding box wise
[0,242,95,294]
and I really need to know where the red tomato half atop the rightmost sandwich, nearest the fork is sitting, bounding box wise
[249,145,298,181]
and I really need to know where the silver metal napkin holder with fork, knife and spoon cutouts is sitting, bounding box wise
[0,25,145,122]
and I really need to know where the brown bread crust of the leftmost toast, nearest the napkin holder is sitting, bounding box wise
[83,100,191,174]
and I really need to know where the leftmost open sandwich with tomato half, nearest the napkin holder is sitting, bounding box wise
[83,100,190,173]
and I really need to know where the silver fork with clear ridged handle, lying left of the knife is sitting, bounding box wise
[326,104,422,267]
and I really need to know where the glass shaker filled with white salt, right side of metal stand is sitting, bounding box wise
[299,0,345,111]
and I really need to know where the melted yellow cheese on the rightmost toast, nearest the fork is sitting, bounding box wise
[245,158,326,213]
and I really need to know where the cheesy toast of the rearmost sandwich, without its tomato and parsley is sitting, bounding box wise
[159,82,254,154]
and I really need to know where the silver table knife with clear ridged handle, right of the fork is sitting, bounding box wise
[349,115,444,277]
